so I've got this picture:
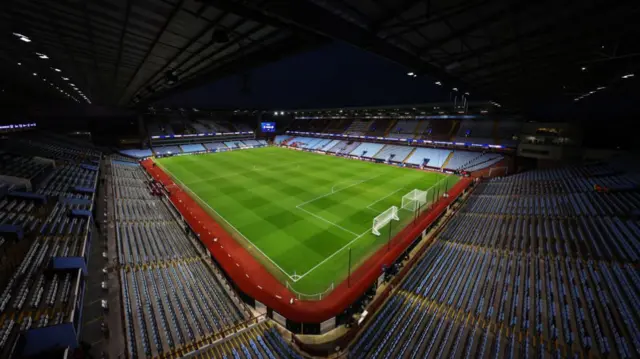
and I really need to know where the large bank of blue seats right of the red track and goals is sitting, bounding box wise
[349,169,640,358]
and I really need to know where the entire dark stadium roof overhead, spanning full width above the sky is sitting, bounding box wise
[0,0,640,106]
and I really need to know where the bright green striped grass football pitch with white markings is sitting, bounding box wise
[155,147,458,299]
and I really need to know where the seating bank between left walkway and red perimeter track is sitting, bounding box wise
[111,162,248,357]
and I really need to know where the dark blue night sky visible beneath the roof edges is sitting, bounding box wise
[161,43,470,110]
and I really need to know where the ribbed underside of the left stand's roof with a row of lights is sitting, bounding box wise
[0,0,325,106]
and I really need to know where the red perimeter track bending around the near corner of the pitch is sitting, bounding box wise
[141,159,472,323]
